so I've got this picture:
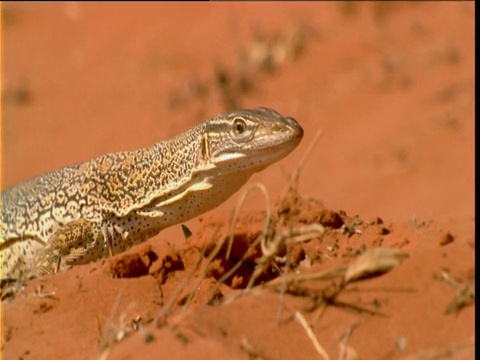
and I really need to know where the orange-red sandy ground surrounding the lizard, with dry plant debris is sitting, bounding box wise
[2,2,475,359]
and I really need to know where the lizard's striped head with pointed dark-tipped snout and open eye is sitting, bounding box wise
[202,107,303,173]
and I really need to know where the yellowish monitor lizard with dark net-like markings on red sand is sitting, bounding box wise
[0,108,303,279]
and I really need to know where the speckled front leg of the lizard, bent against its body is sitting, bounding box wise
[33,219,106,275]
